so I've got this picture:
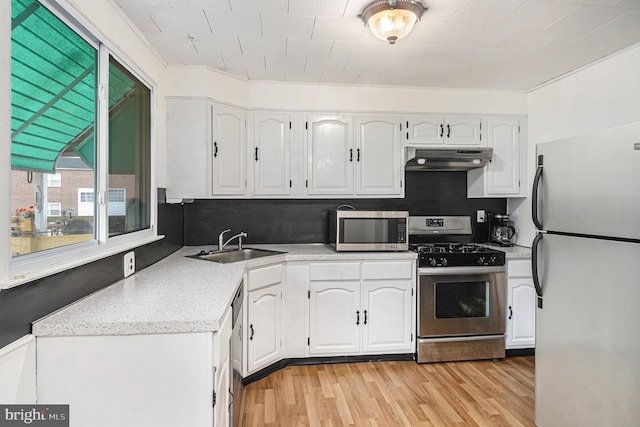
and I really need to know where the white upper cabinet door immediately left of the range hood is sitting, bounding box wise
[355,116,404,196]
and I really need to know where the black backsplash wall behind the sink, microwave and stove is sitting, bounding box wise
[185,172,507,246]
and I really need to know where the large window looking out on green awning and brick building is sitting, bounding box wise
[11,0,155,258]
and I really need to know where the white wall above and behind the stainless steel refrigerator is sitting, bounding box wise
[508,44,640,246]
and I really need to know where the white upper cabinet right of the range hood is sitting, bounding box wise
[467,117,527,197]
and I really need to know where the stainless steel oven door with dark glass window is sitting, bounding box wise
[418,267,507,338]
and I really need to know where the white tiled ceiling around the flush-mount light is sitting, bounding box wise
[115,0,640,91]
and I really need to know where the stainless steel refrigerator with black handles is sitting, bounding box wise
[532,123,640,427]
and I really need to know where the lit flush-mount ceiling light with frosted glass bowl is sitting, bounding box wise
[359,0,427,44]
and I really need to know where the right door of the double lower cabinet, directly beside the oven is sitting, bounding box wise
[362,280,413,353]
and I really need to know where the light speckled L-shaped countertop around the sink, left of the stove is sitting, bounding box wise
[32,244,416,336]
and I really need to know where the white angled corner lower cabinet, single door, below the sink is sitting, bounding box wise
[244,264,284,375]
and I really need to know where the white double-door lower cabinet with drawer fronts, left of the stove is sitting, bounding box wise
[308,261,415,356]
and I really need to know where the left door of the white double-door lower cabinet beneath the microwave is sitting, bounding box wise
[309,280,364,355]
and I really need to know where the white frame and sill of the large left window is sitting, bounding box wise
[5,0,163,290]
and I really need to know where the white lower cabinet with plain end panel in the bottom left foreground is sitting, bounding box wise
[36,310,231,427]
